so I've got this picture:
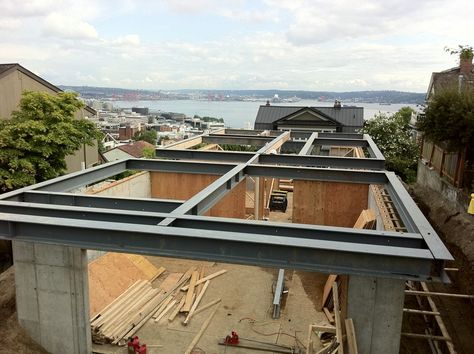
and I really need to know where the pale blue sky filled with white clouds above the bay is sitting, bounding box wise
[0,0,474,92]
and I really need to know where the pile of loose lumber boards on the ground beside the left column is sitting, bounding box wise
[91,267,226,345]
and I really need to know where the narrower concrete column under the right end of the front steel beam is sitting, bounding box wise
[347,275,405,354]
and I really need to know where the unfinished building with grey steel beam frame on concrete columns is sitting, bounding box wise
[0,129,472,354]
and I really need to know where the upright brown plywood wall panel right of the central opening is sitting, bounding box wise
[293,180,369,227]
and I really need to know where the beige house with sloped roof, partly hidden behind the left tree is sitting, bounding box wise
[0,64,99,173]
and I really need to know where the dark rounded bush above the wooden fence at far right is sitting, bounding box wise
[418,87,474,151]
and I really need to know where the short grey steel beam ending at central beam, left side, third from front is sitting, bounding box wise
[21,191,183,213]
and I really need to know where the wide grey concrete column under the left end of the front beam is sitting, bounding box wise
[13,241,92,354]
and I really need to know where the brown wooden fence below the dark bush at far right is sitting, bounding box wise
[421,140,466,188]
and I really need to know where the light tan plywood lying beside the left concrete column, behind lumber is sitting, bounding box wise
[88,252,161,316]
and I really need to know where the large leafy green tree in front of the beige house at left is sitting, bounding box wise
[0,92,100,192]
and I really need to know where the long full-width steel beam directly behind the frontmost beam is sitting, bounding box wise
[0,201,427,249]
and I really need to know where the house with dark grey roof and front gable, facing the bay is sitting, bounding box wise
[254,101,364,133]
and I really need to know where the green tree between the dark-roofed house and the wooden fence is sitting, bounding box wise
[361,107,419,182]
